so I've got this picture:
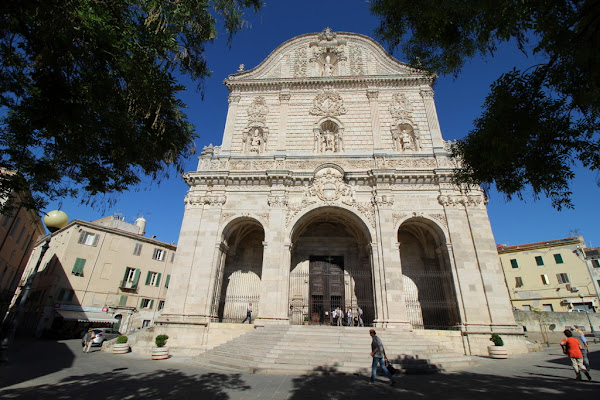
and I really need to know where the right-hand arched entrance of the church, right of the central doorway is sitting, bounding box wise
[398,218,460,329]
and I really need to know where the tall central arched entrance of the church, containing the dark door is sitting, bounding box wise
[289,207,375,325]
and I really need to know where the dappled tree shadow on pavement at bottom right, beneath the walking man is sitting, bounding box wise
[289,352,600,400]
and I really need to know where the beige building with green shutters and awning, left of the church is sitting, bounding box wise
[20,217,176,336]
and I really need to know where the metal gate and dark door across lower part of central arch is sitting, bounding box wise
[290,256,374,325]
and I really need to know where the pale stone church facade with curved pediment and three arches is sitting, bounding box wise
[157,29,526,354]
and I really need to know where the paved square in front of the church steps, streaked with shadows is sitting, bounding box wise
[0,340,600,400]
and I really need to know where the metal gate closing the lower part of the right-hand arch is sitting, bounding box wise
[402,268,460,329]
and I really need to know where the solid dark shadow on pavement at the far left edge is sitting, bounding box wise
[0,339,75,387]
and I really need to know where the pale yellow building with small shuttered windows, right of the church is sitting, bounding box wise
[498,236,600,312]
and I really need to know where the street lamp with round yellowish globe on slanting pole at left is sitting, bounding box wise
[0,210,69,362]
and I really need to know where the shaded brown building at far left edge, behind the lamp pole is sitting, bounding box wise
[0,192,46,320]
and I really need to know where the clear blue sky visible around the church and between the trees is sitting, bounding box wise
[48,0,600,246]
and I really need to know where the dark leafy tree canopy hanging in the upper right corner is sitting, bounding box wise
[371,0,600,209]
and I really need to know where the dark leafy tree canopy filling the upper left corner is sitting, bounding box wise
[0,0,261,211]
